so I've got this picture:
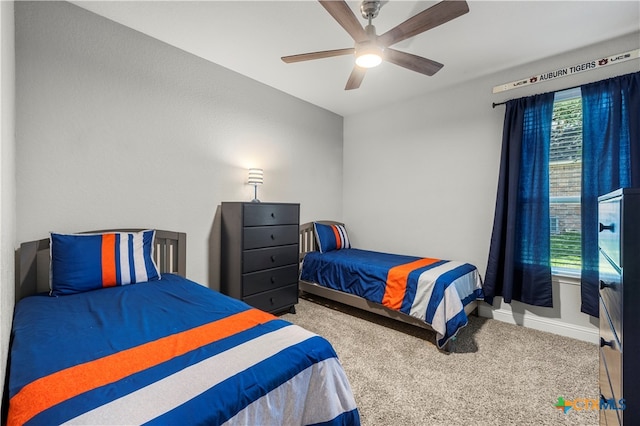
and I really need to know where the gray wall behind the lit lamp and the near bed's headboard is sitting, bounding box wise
[15,2,343,288]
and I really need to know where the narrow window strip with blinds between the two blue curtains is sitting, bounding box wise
[549,88,582,274]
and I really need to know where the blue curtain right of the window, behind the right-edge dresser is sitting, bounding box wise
[581,72,640,317]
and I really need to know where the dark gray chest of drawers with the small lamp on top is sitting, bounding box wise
[220,202,300,313]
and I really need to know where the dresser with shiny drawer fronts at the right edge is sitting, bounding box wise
[598,188,640,425]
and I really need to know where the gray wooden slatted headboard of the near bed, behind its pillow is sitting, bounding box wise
[16,229,187,303]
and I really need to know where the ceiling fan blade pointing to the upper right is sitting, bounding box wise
[378,0,469,46]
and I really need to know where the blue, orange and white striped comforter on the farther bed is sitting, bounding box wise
[300,249,483,347]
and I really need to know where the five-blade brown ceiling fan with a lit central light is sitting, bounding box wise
[282,0,469,90]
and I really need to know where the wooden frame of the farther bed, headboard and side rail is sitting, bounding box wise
[299,220,478,331]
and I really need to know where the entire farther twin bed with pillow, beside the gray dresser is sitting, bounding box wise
[299,221,483,349]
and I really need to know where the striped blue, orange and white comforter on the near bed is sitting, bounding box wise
[8,274,359,425]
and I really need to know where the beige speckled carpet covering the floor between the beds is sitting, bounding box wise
[282,297,599,426]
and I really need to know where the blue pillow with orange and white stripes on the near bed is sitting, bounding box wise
[50,230,160,296]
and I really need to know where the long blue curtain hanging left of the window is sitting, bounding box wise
[483,93,554,307]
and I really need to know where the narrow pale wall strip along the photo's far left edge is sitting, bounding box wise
[0,1,16,412]
